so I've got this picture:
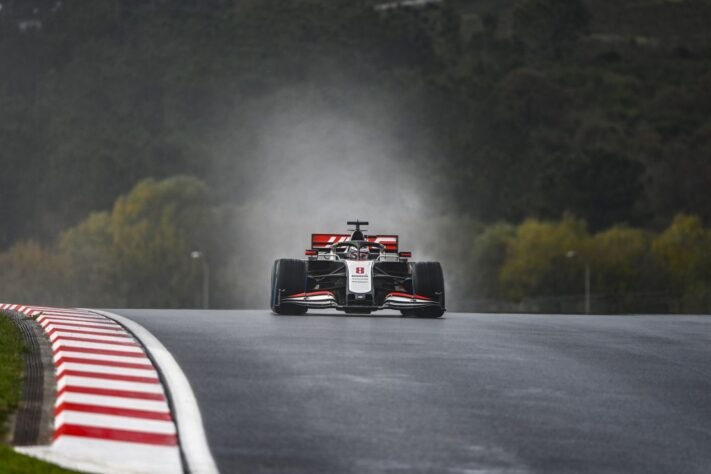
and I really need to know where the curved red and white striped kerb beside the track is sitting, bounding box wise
[0,304,183,472]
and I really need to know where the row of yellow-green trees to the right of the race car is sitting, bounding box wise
[451,214,711,313]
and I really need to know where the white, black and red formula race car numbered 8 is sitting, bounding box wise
[271,220,445,318]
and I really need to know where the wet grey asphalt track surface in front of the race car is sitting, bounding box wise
[114,310,711,474]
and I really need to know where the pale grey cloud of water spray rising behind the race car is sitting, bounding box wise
[210,78,468,307]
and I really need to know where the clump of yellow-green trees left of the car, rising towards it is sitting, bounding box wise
[0,176,220,308]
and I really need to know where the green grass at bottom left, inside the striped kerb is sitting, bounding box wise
[0,313,80,474]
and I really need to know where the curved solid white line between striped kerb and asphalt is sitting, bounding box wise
[89,309,219,474]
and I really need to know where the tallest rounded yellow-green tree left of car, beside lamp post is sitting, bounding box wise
[111,176,212,307]
